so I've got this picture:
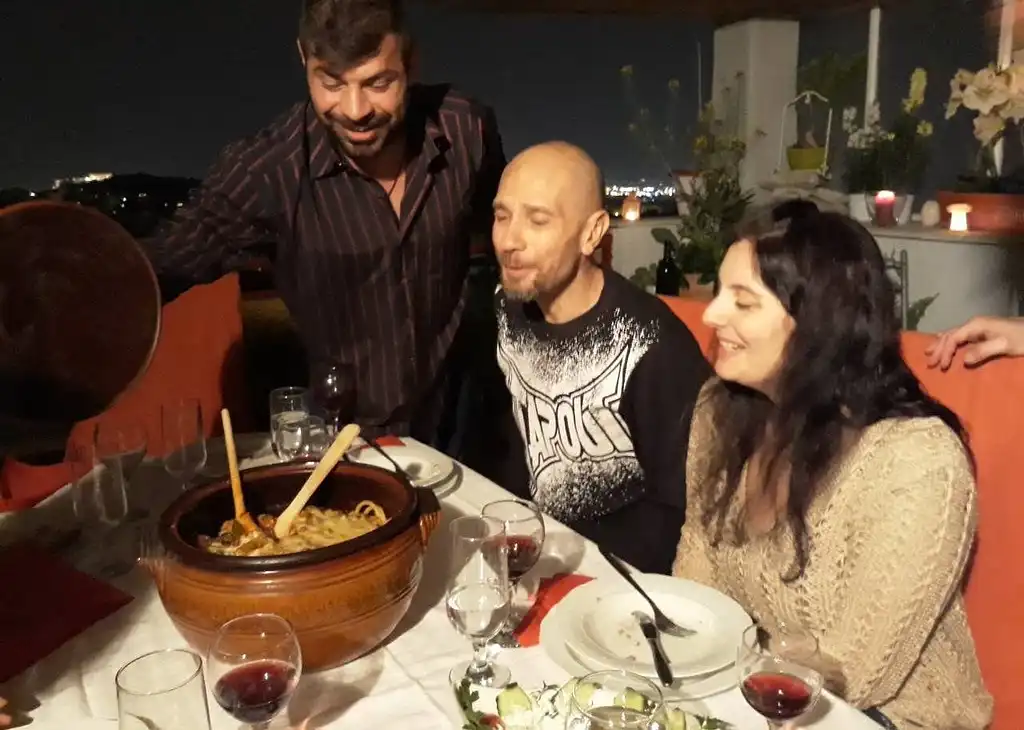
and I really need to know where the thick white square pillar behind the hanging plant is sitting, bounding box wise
[712,19,800,189]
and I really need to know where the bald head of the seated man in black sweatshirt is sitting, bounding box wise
[493,142,608,300]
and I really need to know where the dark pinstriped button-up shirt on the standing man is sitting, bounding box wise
[151,85,505,437]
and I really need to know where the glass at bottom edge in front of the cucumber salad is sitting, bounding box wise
[565,670,668,730]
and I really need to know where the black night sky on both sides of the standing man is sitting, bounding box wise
[0,0,712,187]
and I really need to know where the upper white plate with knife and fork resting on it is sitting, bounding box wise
[560,573,751,678]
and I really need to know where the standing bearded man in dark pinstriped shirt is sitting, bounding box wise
[153,0,505,448]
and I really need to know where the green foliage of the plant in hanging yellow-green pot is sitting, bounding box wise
[794,53,867,147]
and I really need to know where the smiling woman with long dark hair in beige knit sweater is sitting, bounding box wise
[674,203,992,730]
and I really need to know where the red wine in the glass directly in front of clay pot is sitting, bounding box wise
[213,659,296,725]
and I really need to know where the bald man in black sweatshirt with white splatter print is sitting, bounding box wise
[493,142,710,573]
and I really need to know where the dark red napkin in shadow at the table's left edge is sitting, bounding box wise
[0,545,132,682]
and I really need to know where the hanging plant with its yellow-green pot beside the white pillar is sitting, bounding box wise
[785,53,867,170]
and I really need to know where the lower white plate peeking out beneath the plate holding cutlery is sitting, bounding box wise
[540,587,737,700]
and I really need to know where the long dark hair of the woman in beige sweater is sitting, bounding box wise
[702,201,973,582]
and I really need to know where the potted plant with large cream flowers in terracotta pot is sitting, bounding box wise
[938,63,1024,232]
